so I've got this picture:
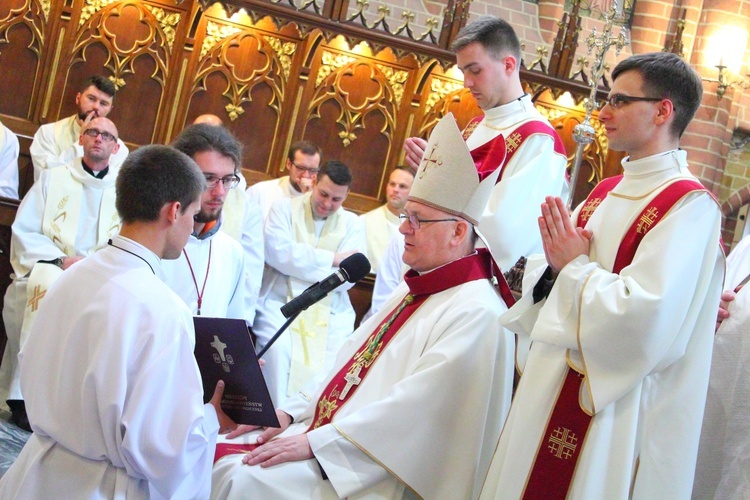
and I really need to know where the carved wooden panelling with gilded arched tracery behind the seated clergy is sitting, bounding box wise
[0,0,608,217]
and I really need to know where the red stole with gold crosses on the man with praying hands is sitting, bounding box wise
[524,175,705,499]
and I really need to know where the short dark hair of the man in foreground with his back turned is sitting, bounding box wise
[115,145,206,223]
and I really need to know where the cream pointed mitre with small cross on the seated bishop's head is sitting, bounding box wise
[409,113,500,226]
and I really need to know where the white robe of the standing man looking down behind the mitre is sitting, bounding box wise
[466,94,569,272]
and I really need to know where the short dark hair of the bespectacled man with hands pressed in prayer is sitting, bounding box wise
[612,52,703,138]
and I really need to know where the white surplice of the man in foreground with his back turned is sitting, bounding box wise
[0,237,219,499]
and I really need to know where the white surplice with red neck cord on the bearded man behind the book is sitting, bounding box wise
[162,225,250,324]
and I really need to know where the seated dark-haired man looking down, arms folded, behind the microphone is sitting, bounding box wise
[253,160,365,404]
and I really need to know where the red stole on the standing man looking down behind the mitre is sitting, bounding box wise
[463,116,567,184]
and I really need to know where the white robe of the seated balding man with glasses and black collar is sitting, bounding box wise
[0,158,119,401]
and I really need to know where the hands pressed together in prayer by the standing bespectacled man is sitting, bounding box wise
[539,196,592,276]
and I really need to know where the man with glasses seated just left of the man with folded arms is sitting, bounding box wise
[246,141,323,220]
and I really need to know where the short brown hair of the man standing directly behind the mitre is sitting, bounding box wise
[451,16,521,62]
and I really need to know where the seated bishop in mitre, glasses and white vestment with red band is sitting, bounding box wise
[212,115,513,499]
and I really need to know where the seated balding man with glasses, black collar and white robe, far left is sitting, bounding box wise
[0,118,120,430]
